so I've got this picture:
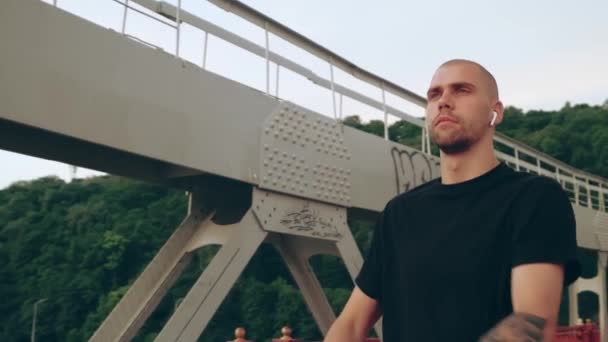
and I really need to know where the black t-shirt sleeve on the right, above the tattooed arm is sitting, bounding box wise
[511,177,580,286]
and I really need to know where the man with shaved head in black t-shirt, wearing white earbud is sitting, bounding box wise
[325,60,580,342]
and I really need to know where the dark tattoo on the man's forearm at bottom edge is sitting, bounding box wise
[479,313,546,342]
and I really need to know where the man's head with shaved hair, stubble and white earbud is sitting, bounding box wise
[426,59,503,154]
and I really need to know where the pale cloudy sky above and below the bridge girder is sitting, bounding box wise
[0,0,608,189]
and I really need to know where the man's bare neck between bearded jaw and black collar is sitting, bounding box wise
[441,140,499,184]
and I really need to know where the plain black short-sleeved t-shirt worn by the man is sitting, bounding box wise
[356,163,580,342]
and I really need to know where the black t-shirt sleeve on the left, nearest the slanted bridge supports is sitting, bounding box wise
[355,200,388,302]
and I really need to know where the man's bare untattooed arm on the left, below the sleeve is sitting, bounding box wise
[324,286,381,342]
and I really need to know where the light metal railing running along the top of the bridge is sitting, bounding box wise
[48,0,608,212]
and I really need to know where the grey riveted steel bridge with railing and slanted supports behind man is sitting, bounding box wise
[0,0,608,341]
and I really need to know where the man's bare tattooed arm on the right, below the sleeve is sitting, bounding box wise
[479,263,564,342]
